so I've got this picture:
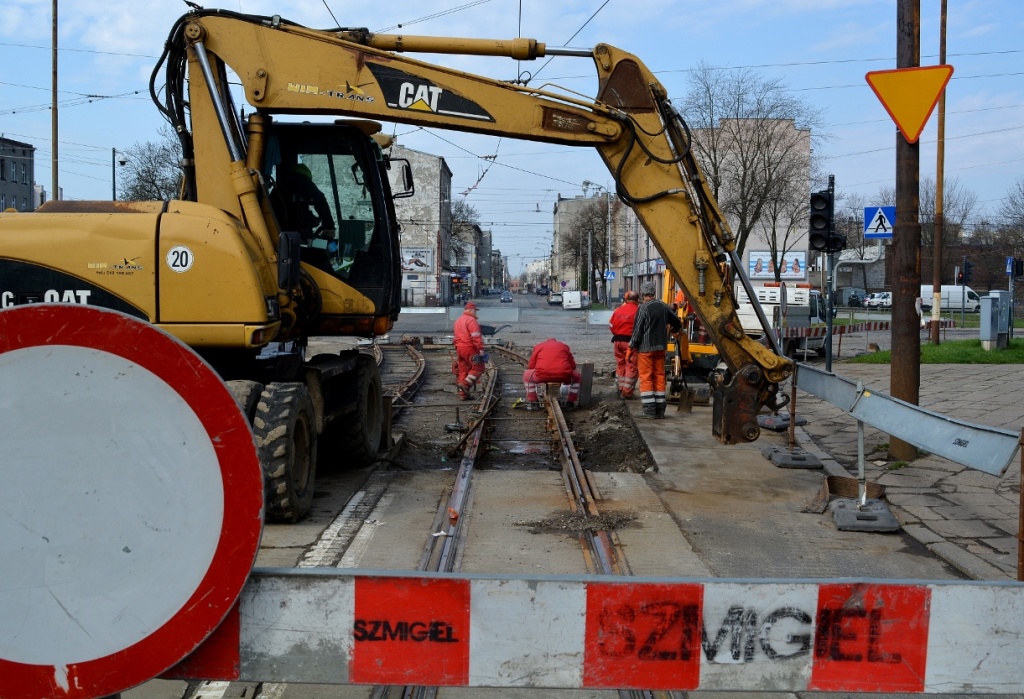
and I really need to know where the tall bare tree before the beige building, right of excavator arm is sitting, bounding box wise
[680,63,822,254]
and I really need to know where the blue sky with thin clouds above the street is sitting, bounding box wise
[0,0,1024,273]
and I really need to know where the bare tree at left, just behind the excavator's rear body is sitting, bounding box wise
[118,124,181,202]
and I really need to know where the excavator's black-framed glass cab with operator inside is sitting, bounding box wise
[262,120,400,333]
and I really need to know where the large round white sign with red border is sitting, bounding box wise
[0,304,263,699]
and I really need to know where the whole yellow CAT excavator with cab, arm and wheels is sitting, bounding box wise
[0,9,793,520]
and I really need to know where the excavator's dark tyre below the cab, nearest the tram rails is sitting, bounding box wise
[328,356,384,467]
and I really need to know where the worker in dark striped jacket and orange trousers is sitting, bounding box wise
[630,281,683,420]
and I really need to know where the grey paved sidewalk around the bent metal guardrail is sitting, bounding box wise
[796,361,1024,580]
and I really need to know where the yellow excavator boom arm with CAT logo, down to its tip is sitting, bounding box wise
[183,10,793,443]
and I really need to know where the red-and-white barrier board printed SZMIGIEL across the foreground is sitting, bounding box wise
[163,570,1024,694]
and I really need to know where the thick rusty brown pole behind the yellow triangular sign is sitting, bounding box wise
[889,0,921,462]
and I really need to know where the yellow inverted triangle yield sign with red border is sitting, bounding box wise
[864,65,953,143]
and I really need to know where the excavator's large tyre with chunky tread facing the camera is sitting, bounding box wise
[253,383,316,522]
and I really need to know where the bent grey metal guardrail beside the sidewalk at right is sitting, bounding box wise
[794,363,1020,476]
